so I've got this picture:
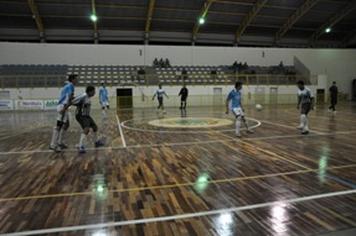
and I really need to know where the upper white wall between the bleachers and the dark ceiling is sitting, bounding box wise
[0,43,356,94]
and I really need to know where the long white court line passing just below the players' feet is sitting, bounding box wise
[0,130,356,155]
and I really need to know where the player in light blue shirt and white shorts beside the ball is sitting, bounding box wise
[226,82,253,138]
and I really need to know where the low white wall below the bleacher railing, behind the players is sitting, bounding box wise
[1,85,317,108]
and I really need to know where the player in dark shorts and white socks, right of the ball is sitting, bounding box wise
[297,80,314,134]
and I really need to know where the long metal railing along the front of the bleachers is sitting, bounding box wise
[0,74,316,88]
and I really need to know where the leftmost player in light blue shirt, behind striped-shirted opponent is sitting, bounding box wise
[49,74,78,152]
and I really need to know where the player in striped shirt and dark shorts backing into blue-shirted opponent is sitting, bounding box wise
[72,85,104,153]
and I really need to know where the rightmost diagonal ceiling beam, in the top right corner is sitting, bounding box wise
[310,0,356,45]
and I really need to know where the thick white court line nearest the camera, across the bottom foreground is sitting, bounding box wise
[0,189,356,236]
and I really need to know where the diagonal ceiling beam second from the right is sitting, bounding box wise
[274,0,320,43]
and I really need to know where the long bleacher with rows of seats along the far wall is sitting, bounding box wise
[0,65,306,88]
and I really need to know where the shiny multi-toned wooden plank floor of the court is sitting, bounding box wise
[0,104,356,236]
